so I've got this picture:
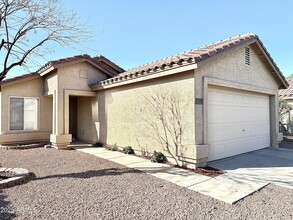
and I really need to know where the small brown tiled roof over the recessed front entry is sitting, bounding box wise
[37,54,125,77]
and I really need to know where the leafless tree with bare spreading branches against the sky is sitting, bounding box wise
[0,0,91,82]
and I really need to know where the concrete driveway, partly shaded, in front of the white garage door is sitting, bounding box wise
[208,148,293,189]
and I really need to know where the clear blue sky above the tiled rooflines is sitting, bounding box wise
[8,0,293,77]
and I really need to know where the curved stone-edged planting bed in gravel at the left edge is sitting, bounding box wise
[0,167,35,189]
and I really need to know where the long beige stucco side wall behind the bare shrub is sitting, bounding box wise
[98,71,195,156]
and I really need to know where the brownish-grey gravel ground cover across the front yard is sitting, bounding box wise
[0,148,293,220]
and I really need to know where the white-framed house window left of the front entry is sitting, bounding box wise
[9,97,39,131]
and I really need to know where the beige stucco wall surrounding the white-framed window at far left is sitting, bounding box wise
[0,77,52,144]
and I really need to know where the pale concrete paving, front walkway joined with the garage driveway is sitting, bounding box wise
[73,146,293,204]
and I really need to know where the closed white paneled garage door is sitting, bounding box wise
[208,88,270,161]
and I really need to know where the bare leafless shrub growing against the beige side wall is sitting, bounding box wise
[139,87,186,165]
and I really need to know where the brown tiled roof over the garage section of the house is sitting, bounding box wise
[90,33,288,88]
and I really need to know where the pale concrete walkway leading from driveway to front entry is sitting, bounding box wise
[72,146,268,204]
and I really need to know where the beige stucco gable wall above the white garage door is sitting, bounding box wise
[195,45,278,92]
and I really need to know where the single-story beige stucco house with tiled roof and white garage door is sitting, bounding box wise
[0,33,288,166]
